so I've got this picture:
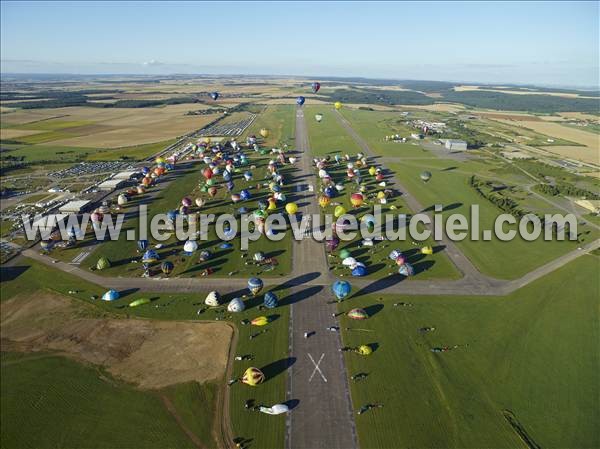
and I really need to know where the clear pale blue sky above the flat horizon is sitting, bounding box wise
[0,0,600,88]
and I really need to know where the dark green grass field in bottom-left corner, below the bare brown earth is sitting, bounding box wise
[1,353,202,448]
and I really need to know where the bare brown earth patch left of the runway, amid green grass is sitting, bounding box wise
[0,292,233,389]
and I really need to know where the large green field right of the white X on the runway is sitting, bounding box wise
[340,256,600,448]
